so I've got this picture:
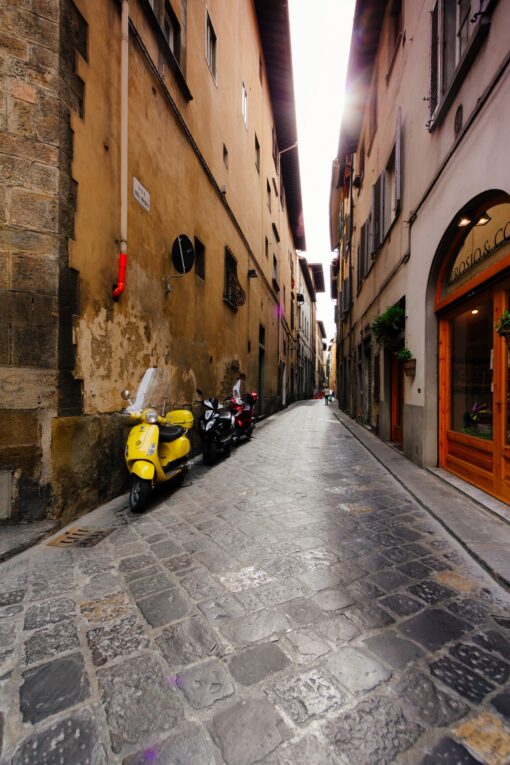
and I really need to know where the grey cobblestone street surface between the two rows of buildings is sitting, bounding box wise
[0,402,510,765]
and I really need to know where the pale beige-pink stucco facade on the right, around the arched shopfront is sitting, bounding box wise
[330,0,510,496]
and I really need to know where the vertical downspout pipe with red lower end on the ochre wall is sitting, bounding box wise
[112,0,129,301]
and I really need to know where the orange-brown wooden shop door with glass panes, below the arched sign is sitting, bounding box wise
[439,284,510,502]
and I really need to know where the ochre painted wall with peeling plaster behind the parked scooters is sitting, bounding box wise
[47,0,297,518]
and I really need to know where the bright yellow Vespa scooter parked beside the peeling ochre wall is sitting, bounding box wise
[121,390,193,513]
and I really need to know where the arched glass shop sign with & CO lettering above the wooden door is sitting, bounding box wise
[446,204,510,287]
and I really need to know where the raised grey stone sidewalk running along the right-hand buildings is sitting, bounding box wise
[333,410,510,589]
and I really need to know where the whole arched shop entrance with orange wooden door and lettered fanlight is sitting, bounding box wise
[435,192,510,503]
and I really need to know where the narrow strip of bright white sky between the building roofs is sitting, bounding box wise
[289,0,355,342]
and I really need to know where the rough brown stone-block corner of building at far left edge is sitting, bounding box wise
[0,0,87,519]
